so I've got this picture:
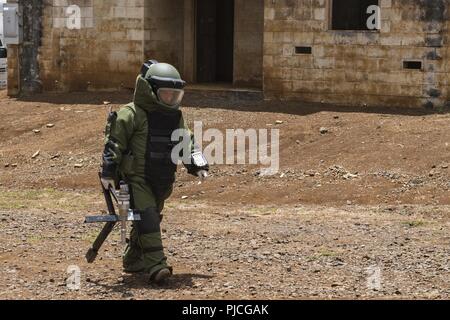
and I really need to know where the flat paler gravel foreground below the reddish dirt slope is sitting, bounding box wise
[0,201,450,299]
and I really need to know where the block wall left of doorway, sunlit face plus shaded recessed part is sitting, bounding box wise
[35,0,184,91]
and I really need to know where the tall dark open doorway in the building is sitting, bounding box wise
[196,0,234,83]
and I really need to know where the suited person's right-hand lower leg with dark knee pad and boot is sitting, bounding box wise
[136,208,172,283]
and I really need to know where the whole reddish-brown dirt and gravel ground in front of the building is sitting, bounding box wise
[0,92,450,299]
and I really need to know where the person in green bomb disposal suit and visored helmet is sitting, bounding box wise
[101,60,209,283]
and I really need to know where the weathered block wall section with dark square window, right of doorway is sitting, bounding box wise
[264,0,450,107]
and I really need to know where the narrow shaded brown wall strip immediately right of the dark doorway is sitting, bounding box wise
[233,0,264,88]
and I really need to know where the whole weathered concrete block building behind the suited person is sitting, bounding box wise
[8,0,450,108]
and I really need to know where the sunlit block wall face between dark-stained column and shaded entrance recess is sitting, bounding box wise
[39,0,144,91]
